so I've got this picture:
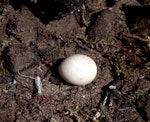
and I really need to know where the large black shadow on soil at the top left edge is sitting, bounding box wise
[10,0,67,24]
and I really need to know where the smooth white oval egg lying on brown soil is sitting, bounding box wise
[58,54,97,85]
